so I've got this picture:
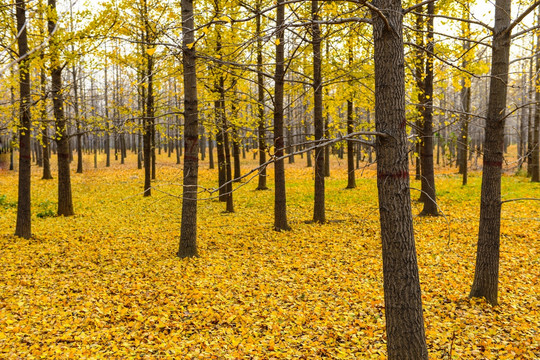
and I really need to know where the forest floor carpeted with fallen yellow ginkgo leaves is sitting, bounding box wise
[0,150,540,359]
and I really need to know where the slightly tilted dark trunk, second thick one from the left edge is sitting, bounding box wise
[48,0,74,216]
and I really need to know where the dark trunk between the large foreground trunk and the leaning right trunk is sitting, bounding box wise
[420,2,439,216]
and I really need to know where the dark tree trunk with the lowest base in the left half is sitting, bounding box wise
[178,0,199,258]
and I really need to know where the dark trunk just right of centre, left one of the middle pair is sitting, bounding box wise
[274,0,290,231]
